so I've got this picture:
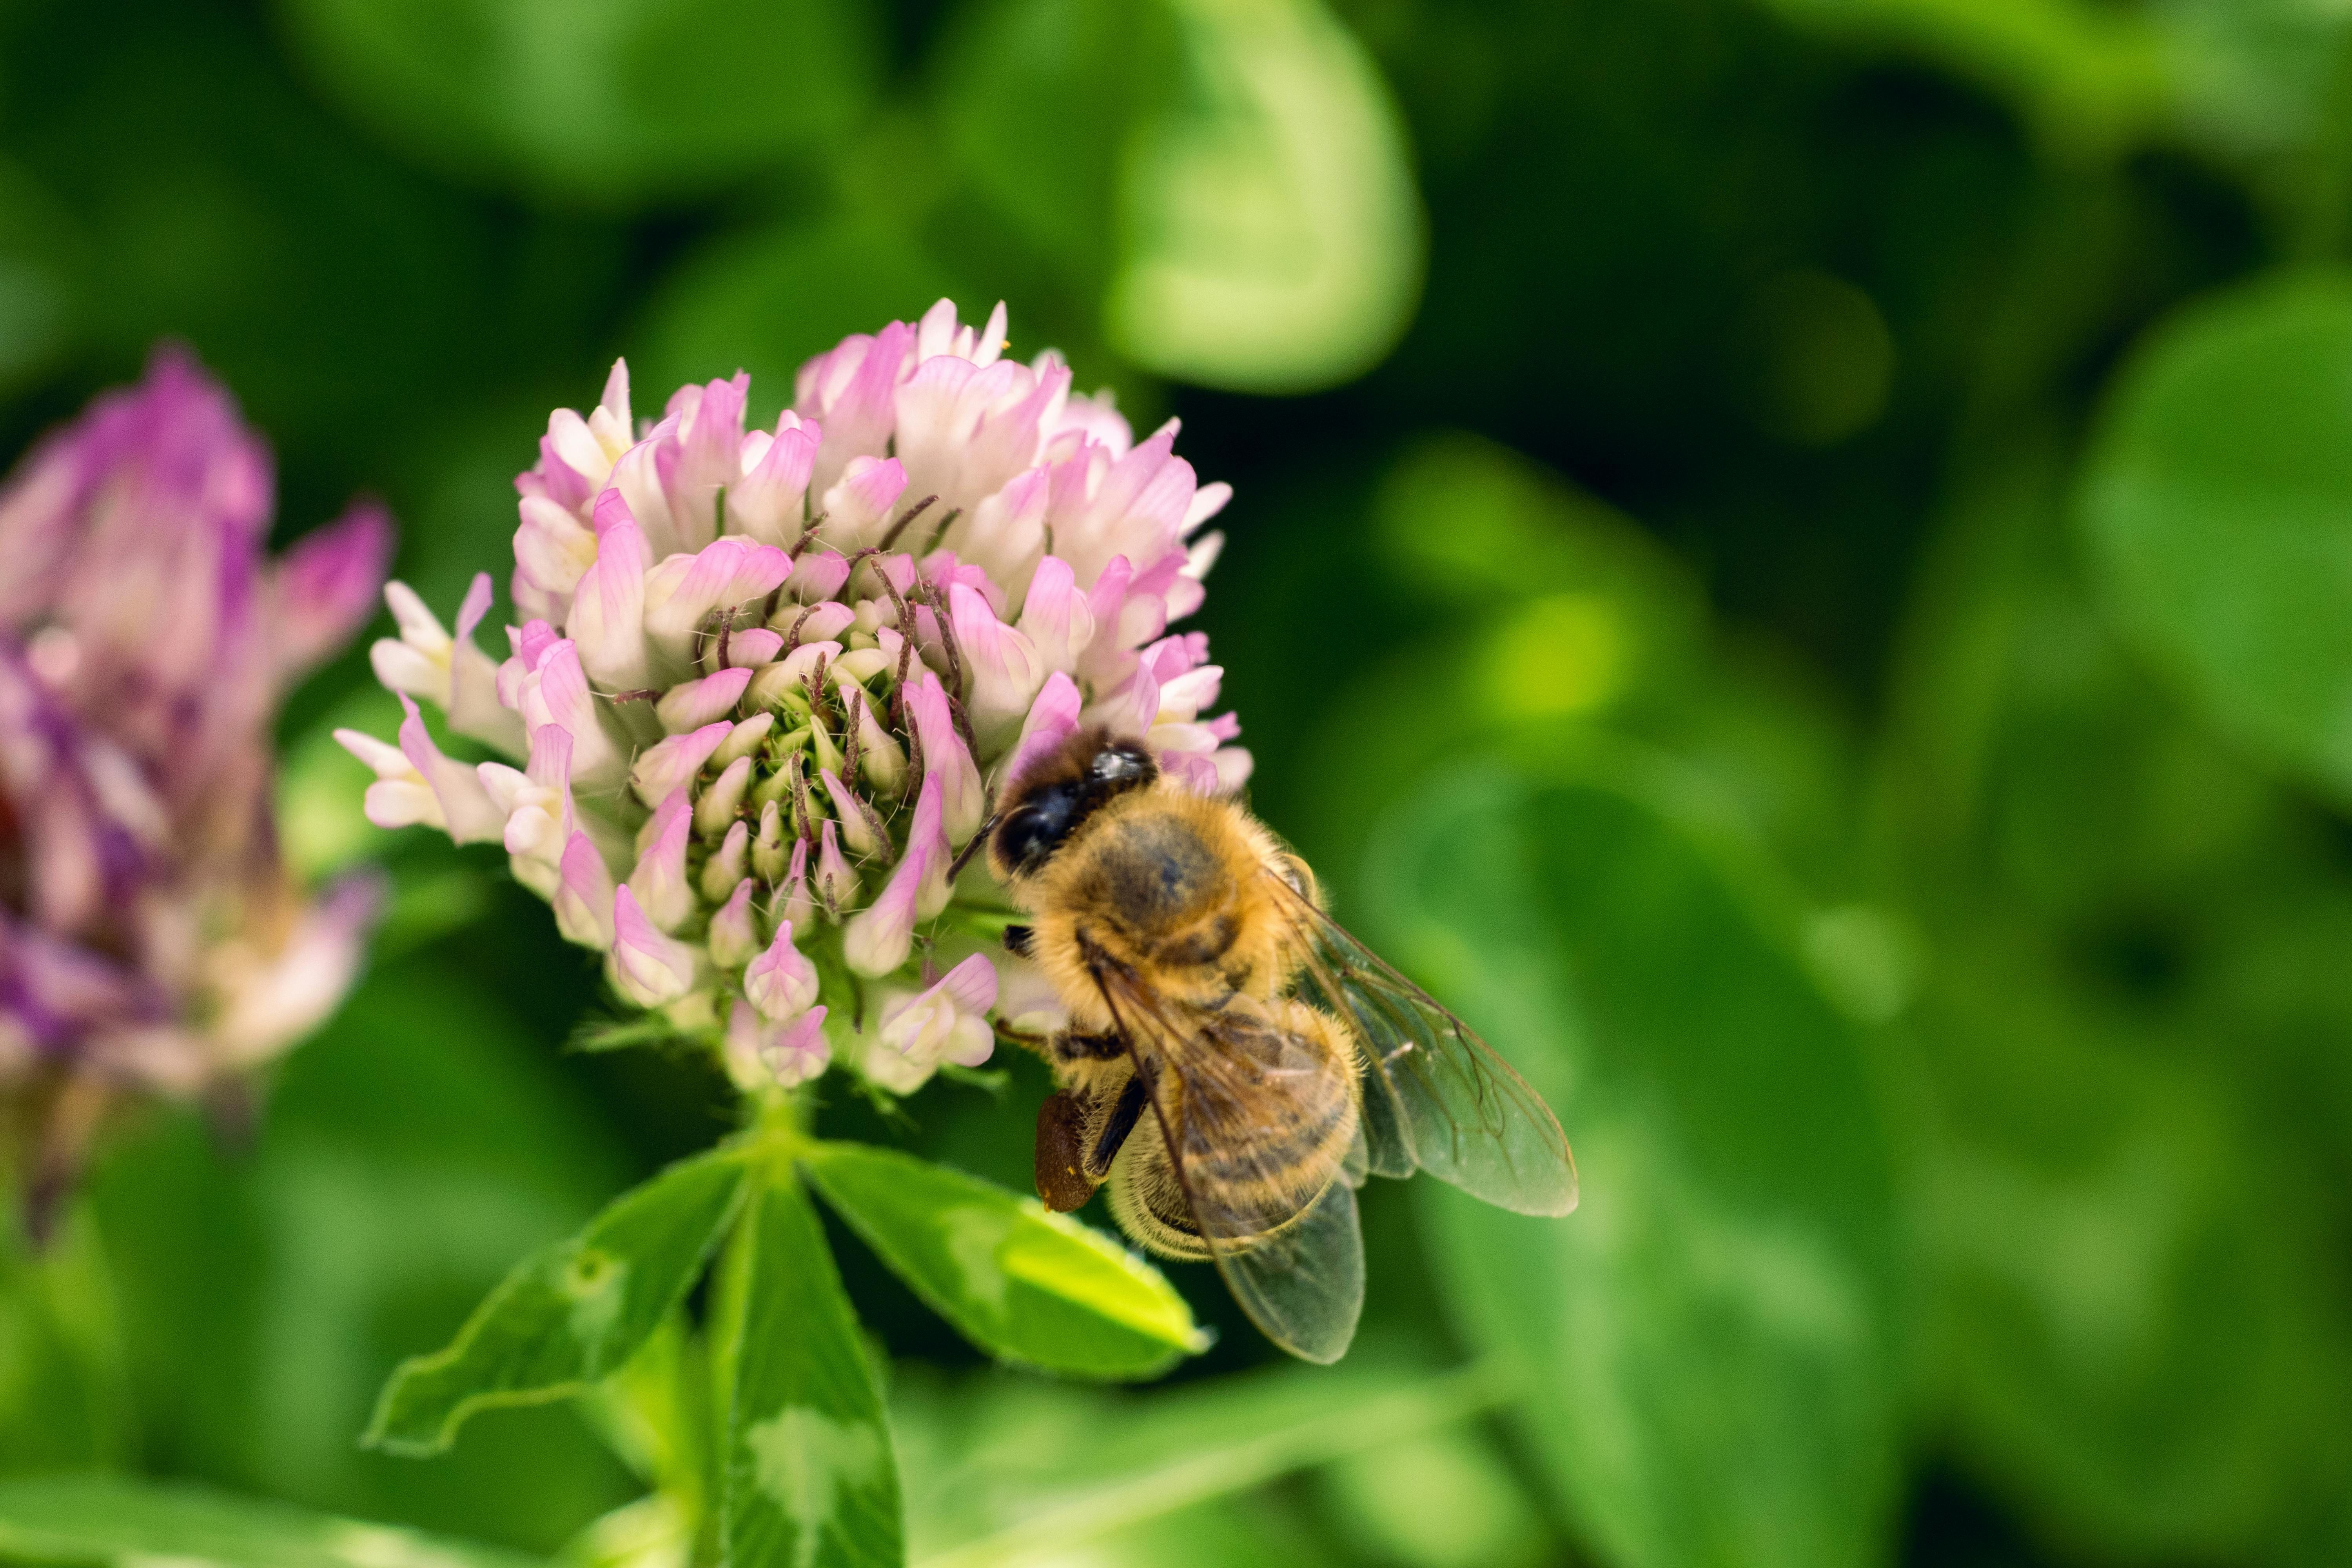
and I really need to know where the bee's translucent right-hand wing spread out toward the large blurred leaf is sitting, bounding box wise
[1265,872,1576,1215]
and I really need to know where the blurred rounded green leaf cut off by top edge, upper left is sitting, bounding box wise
[267,0,877,207]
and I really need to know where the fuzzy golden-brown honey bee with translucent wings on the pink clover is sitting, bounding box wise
[985,729,1576,1361]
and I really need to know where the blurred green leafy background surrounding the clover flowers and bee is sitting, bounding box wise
[0,0,2352,1568]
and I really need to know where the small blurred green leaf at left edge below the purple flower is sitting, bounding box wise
[0,1203,132,1472]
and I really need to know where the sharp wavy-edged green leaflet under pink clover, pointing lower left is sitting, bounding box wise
[367,1150,743,1455]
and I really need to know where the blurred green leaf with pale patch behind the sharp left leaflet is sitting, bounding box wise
[92,964,633,1552]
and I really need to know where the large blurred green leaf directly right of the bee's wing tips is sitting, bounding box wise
[1364,762,1900,1568]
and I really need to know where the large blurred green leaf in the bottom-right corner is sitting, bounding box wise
[1915,940,2352,1561]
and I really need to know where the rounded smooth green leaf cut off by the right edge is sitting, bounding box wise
[2082,270,2352,802]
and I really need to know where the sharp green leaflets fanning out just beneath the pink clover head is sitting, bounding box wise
[348,1124,1207,1563]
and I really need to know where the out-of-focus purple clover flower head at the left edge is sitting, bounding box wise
[0,348,386,1199]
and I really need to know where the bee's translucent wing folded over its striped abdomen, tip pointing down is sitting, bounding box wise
[1094,964,1364,1366]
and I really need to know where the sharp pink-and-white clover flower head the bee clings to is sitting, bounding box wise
[346,301,1249,1093]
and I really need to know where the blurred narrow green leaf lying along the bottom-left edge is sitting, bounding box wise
[0,1476,536,1568]
